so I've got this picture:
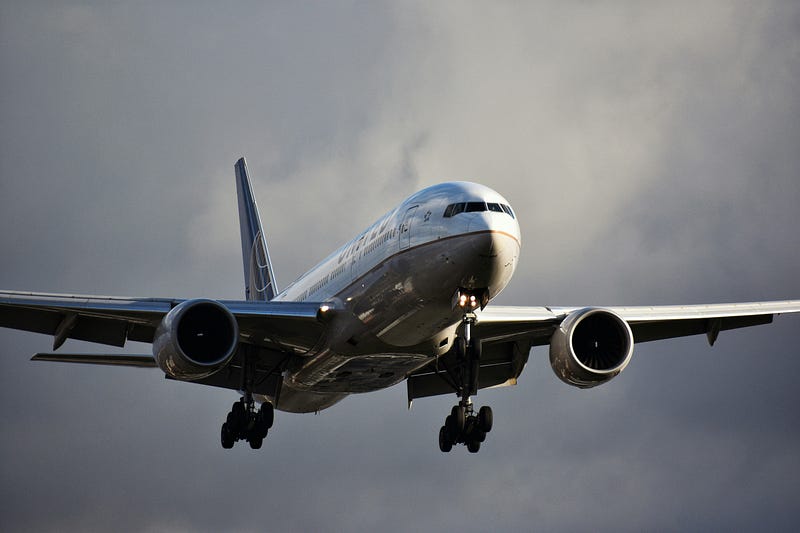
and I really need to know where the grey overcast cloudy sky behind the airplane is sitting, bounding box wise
[0,1,800,532]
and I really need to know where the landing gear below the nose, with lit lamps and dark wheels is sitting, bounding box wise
[439,306,494,453]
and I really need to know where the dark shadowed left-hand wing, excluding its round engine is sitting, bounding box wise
[0,291,324,351]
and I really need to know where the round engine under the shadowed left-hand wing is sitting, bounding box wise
[153,299,239,380]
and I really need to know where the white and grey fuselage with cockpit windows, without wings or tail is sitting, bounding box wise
[268,182,521,412]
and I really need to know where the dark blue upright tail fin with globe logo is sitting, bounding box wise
[234,157,278,301]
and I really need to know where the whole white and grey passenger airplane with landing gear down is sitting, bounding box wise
[0,158,800,453]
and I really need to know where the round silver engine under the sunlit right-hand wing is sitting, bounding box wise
[550,307,633,389]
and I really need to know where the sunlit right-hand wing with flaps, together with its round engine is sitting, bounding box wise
[408,300,800,400]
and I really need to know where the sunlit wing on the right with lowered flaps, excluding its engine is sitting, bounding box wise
[407,300,800,402]
